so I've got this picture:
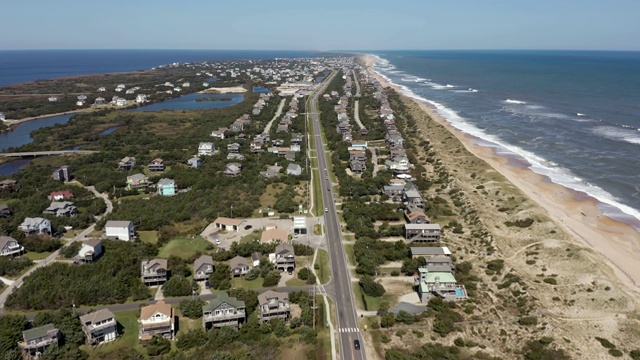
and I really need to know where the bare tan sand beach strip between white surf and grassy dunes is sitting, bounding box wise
[363,55,640,296]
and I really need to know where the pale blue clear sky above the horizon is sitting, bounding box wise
[0,0,640,50]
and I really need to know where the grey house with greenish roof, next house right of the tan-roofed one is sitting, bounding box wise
[202,292,247,330]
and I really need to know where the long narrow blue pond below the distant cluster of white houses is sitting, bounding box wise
[125,93,244,112]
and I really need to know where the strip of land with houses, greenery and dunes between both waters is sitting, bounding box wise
[0,54,640,359]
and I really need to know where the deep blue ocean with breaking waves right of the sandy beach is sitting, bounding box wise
[374,51,640,230]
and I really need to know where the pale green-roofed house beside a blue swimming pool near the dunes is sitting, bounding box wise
[416,267,468,303]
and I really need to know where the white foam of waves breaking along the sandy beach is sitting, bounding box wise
[364,54,640,225]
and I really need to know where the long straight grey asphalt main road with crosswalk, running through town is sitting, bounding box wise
[307,72,366,360]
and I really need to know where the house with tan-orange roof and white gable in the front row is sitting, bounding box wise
[138,300,176,344]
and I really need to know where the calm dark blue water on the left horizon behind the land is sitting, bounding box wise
[0,50,317,86]
